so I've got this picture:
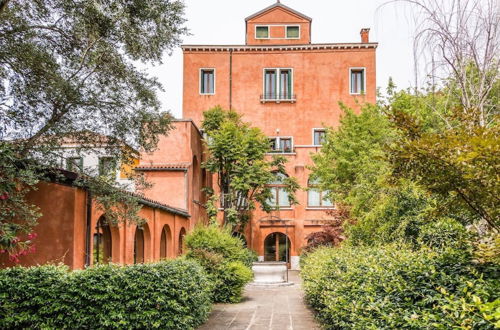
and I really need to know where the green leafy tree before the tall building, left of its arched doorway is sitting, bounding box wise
[202,107,299,230]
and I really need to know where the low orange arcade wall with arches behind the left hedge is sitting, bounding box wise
[0,182,191,269]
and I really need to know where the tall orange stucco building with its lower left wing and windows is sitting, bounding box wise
[141,2,377,268]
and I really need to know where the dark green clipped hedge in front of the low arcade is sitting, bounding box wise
[0,260,211,329]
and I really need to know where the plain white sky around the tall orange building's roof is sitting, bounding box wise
[148,0,414,118]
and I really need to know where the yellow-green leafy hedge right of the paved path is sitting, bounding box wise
[301,246,500,329]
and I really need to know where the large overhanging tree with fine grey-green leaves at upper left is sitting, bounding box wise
[0,0,186,255]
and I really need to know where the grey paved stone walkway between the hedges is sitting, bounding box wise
[199,271,320,330]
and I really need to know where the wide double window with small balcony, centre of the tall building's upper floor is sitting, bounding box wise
[263,68,294,101]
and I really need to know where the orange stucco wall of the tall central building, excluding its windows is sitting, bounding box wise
[183,4,377,267]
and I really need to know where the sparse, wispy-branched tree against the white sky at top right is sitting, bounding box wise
[392,0,500,129]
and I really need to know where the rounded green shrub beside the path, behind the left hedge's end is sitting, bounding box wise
[186,225,255,303]
